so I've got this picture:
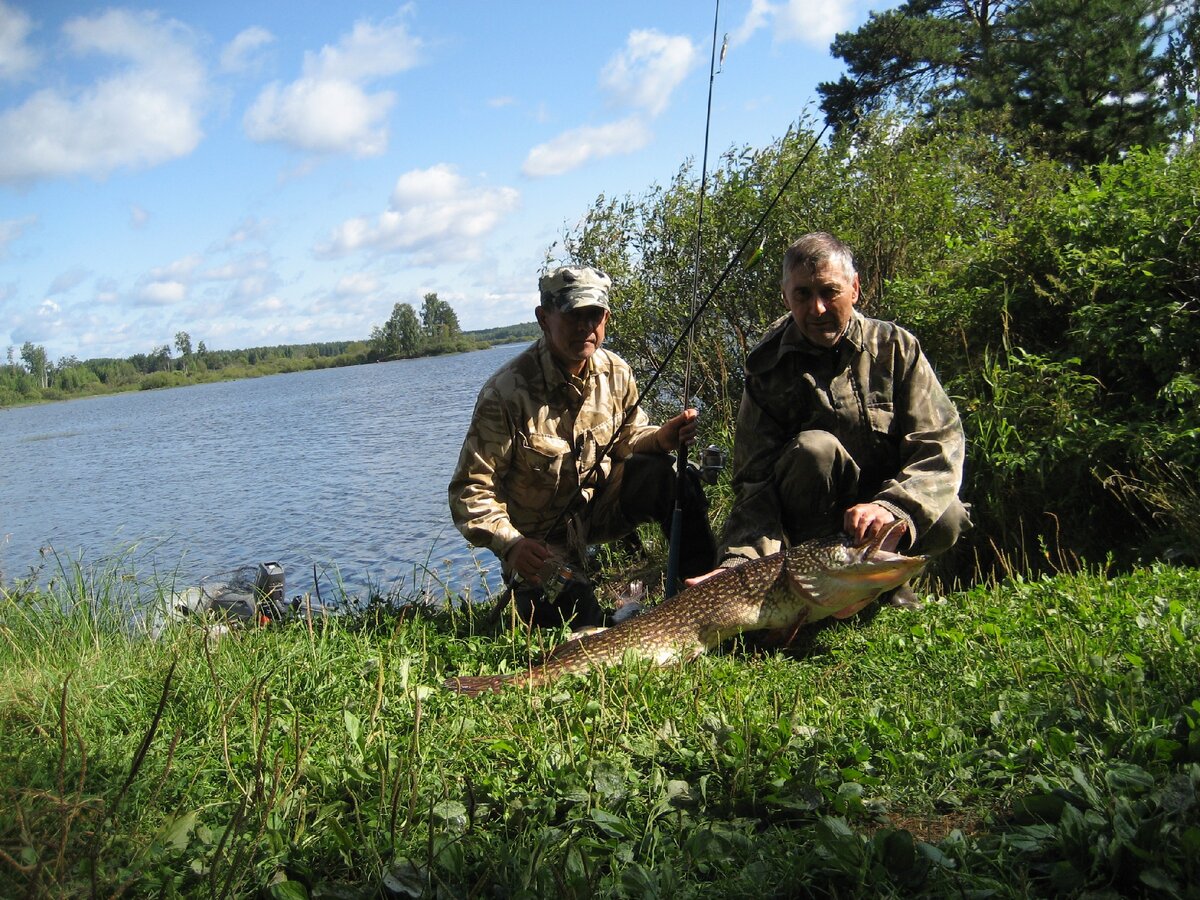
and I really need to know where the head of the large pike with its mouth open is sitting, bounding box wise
[785,522,928,622]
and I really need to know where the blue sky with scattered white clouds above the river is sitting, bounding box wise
[0,0,890,360]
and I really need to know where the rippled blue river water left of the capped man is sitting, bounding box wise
[0,344,524,601]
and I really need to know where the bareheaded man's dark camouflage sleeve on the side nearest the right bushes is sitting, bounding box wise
[874,349,966,542]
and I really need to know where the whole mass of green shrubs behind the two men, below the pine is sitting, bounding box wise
[563,114,1200,574]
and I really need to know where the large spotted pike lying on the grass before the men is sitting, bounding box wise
[445,522,925,696]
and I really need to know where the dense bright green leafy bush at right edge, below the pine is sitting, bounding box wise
[950,149,1200,566]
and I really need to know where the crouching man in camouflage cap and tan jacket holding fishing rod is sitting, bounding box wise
[449,266,716,625]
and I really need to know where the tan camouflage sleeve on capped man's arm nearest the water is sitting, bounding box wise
[449,389,522,560]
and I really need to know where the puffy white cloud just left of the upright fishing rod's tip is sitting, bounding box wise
[600,30,697,116]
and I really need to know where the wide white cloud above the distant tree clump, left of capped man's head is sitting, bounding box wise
[314,163,520,265]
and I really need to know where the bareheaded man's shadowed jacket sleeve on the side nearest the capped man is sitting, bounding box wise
[718,380,790,568]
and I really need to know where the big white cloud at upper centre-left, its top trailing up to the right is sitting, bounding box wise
[242,10,421,156]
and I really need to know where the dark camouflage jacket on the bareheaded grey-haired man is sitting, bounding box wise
[720,311,966,565]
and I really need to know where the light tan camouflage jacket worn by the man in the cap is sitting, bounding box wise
[449,338,660,560]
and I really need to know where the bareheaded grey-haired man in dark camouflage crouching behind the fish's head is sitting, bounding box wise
[721,233,970,604]
